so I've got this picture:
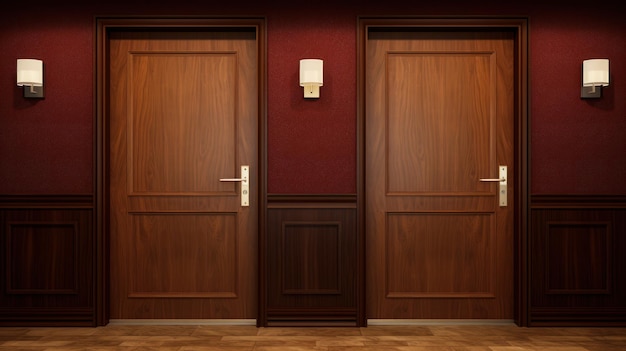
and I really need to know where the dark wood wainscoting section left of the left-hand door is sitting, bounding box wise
[0,195,97,326]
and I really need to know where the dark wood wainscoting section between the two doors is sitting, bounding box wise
[261,195,360,326]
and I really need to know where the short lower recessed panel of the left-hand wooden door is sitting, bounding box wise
[125,213,237,298]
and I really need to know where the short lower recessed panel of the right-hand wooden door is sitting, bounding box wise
[385,212,496,298]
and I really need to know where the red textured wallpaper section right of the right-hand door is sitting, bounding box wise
[530,9,626,194]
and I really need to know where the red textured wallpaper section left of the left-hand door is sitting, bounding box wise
[0,10,94,194]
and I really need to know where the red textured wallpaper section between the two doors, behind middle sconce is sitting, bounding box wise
[268,12,356,194]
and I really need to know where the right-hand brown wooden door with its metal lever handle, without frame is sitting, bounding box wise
[365,28,516,319]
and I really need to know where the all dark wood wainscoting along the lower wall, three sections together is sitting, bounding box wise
[0,195,626,327]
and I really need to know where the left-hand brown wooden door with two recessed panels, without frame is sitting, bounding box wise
[108,28,259,319]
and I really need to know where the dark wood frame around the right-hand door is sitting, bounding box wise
[357,16,530,326]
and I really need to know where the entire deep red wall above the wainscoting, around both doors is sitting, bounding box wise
[0,1,626,194]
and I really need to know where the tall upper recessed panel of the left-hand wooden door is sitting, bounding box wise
[127,51,238,195]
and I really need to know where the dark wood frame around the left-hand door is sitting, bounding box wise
[93,16,267,326]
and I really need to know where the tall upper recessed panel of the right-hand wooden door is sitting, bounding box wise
[385,51,495,194]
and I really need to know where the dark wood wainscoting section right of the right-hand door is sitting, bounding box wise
[528,195,626,326]
